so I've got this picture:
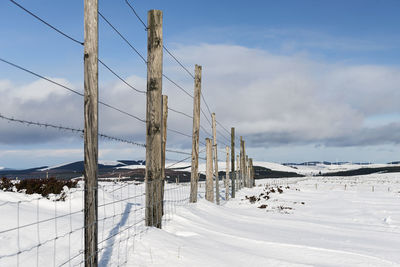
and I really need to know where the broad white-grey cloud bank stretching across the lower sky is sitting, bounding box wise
[0,44,400,151]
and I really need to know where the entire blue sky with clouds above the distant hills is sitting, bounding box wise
[0,0,400,168]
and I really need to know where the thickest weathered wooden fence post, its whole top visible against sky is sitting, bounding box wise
[145,10,163,228]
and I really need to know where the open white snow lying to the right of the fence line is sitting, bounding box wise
[129,173,400,267]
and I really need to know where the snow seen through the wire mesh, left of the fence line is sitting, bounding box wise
[0,180,211,267]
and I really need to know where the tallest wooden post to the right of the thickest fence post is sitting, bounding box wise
[190,65,201,203]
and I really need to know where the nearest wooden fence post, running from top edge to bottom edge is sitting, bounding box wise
[83,0,99,266]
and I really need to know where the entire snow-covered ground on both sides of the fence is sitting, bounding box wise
[0,173,400,266]
